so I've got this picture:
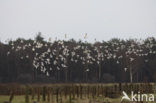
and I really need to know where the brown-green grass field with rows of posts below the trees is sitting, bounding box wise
[0,83,155,103]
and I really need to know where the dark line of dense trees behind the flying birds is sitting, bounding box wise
[0,34,156,83]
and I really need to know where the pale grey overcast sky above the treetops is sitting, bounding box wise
[0,0,156,41]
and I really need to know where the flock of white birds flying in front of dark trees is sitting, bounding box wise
[7,38,156,81]
